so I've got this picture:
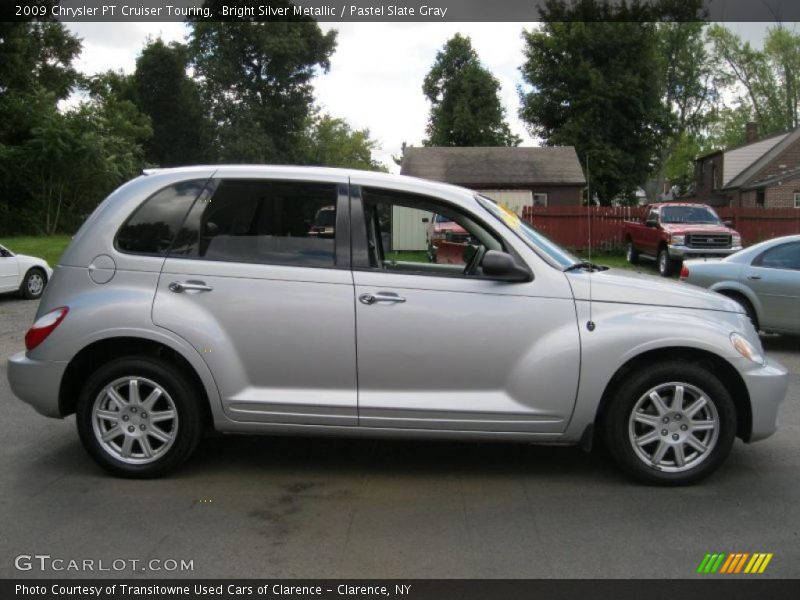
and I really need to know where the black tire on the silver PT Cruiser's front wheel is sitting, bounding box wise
[602,361,736,486]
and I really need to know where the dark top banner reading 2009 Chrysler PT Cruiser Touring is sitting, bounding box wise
[0,0,800,22]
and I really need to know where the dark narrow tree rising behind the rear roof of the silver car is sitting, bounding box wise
[131,39,212,167]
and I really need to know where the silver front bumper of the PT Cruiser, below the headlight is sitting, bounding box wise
[737,358,789,442]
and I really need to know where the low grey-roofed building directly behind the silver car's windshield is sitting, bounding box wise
[400,146,586,206]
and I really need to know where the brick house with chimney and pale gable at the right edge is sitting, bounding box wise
[693,123,800,209]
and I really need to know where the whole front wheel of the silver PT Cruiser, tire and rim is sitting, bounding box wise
[604,361,736,485]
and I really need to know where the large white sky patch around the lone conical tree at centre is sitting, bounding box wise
[314,23,533,168]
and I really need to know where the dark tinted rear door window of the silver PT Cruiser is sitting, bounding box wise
[172,179,337,267]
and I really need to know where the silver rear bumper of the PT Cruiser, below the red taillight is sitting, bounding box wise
[8,352,67,418]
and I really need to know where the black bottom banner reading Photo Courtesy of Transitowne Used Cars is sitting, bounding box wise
[0,576,800,600]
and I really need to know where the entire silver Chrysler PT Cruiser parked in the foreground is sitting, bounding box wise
[8,166,787,484]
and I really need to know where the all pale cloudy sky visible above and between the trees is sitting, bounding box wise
[66,23,770,171]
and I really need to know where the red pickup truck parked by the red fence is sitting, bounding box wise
[622,202,742,277]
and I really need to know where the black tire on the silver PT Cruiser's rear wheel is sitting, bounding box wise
[76,356,203,479]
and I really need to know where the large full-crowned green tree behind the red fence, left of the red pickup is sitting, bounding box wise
[520,19,665,204]
